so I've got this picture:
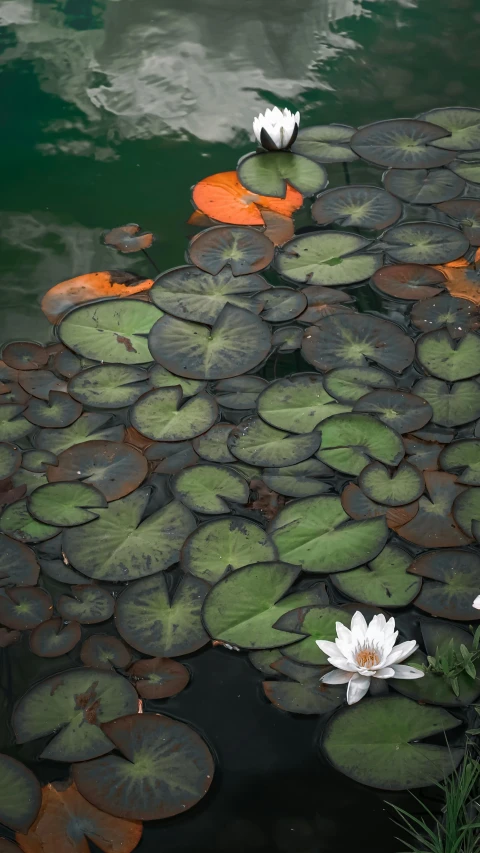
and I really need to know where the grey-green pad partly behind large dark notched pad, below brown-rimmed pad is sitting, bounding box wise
[150,262,270,325]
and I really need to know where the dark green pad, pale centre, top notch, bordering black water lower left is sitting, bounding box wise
[115,574,210,657]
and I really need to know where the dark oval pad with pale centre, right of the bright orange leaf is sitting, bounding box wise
[312,184,402,231]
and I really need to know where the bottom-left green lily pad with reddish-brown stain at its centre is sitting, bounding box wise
[12,668,138,762]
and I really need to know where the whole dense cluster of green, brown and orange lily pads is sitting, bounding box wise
[0,109,480,853]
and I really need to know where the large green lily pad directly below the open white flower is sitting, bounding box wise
[322,696,463,791]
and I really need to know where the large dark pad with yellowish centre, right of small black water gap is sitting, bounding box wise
[302,313,415,373]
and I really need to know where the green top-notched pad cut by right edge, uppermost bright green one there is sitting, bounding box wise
[413,378,480,427]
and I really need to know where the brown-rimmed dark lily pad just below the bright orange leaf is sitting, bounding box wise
[188,225,274,275]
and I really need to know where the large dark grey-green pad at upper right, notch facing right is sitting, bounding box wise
[350,118,454,169]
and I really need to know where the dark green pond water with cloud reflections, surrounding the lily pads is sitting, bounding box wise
[0,0,480,853]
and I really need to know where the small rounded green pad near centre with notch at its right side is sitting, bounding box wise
[172,463,249,515]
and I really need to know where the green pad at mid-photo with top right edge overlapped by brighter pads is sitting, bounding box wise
[227,417,320,466]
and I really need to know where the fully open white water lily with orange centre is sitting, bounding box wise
[317,610,425,705]
